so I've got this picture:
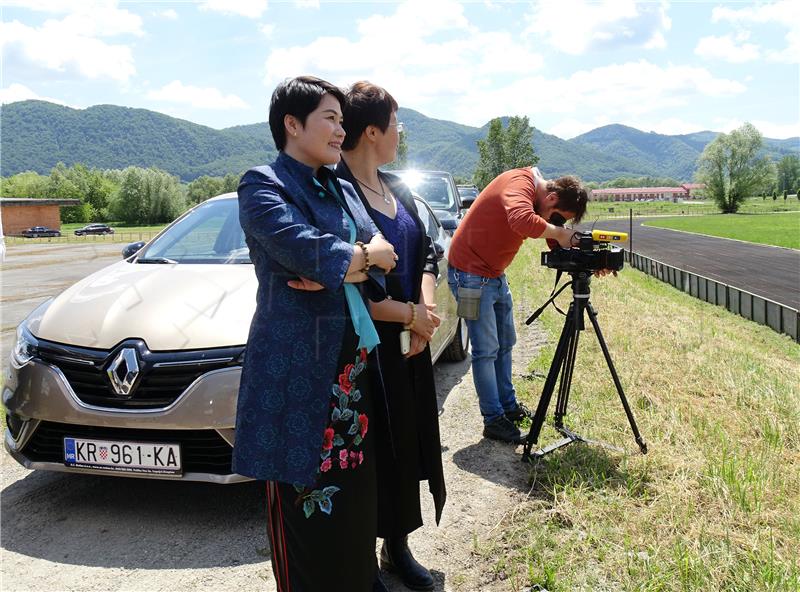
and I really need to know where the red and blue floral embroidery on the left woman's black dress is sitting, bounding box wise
[294,349,369,518]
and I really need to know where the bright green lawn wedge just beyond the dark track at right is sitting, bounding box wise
[646,212,800,249]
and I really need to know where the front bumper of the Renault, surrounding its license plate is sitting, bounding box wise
[3,360,250,483]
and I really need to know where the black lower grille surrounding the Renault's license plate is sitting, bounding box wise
[22,421,233,475]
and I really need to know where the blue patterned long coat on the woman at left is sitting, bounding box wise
[233,152,380,486]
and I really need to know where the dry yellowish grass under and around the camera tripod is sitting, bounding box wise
[490,241,800,592]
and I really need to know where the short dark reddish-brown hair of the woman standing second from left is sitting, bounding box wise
[342,80,397,150]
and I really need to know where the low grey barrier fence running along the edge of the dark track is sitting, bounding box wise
[625,251,800,343]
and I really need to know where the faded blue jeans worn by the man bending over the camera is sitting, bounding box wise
[447,267,517,424]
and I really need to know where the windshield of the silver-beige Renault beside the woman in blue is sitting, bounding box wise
[136,199,250,263]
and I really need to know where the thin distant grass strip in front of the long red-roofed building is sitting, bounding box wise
[587,197,800,220]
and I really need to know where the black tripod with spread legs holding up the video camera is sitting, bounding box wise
[522,271,647,461]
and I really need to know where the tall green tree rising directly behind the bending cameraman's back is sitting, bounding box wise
[473,117,539,189]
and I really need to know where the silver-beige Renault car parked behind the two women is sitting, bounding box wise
[3,193,468,483]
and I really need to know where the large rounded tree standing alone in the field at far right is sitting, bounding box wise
[696,123,772,214]
